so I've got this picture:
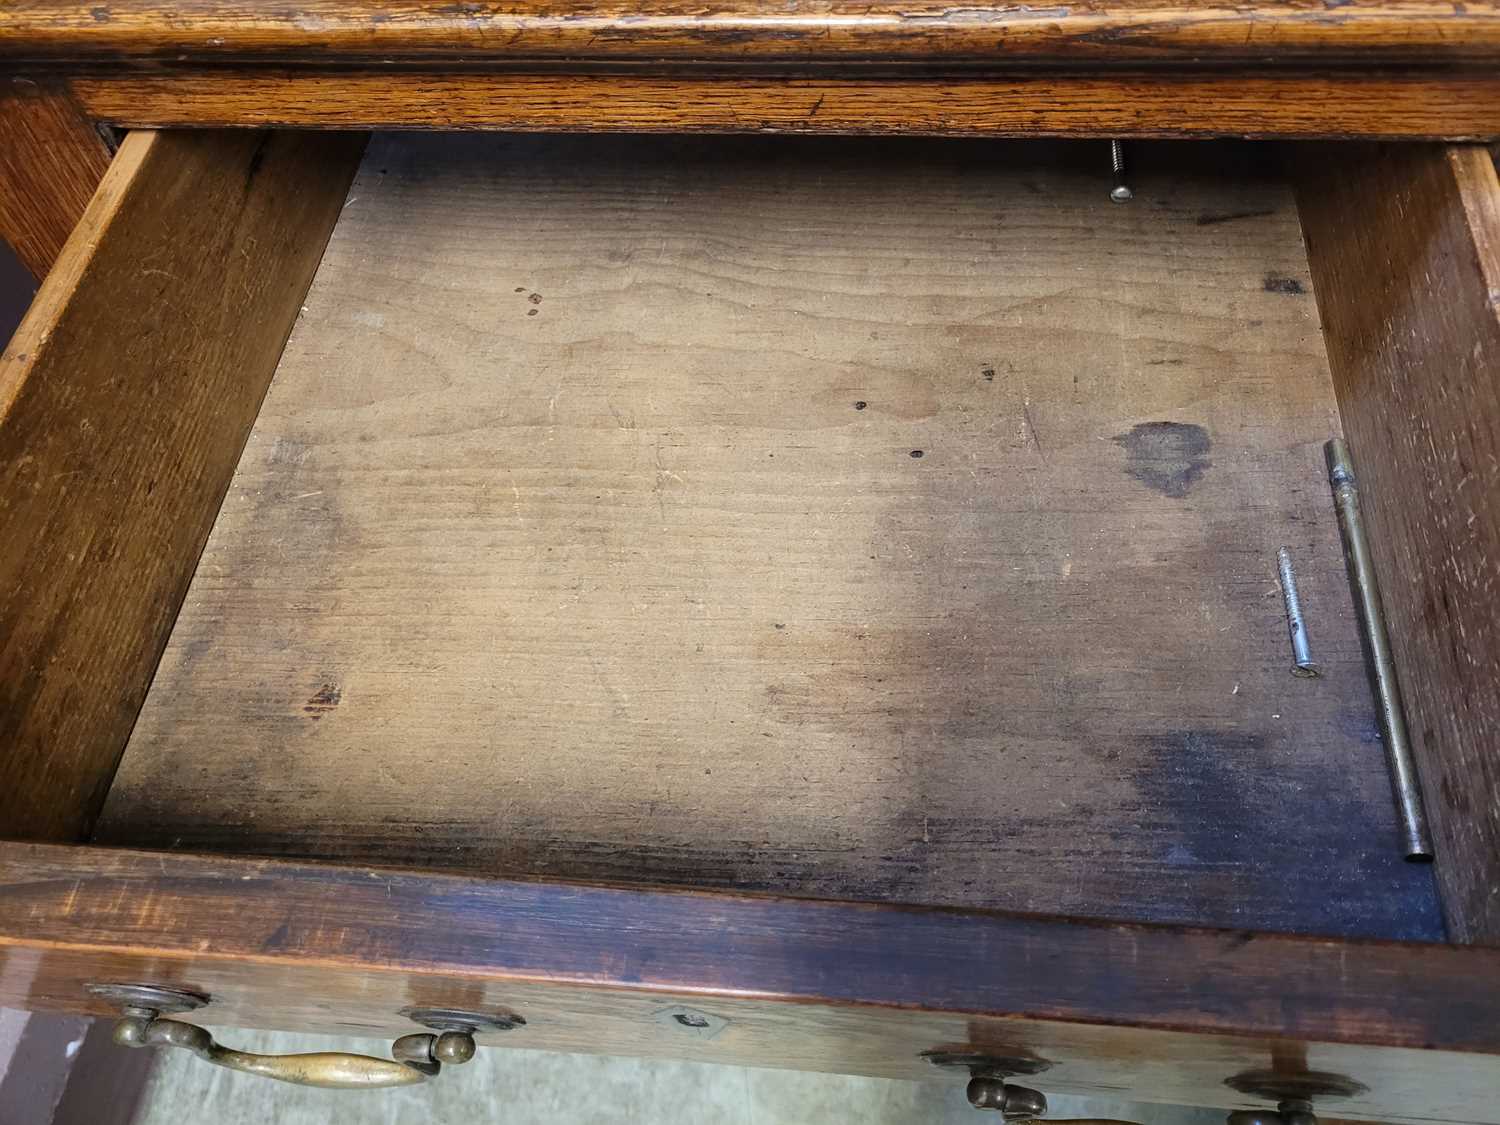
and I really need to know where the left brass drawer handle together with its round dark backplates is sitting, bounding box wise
[90,984,525,1091]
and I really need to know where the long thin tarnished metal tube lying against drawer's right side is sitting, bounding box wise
[1323,438,1433,863]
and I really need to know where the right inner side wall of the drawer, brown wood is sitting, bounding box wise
[1301,146,1500,945]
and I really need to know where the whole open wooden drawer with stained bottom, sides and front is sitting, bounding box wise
[0,132,1500,1122]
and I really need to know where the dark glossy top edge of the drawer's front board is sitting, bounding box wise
[0,843,1500,1055]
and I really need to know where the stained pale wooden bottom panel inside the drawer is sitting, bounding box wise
[99,137,1437,936]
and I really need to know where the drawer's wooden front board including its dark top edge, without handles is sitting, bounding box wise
[0,845,1500,1124]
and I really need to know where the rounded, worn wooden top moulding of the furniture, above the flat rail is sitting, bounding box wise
[0,0,1500,66]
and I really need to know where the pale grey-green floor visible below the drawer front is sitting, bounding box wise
[137,1031,1224,1125]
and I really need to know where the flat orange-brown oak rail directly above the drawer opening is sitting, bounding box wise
[72,71,1500,140]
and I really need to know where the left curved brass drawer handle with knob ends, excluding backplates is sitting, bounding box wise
[114,1008,474,1091]
